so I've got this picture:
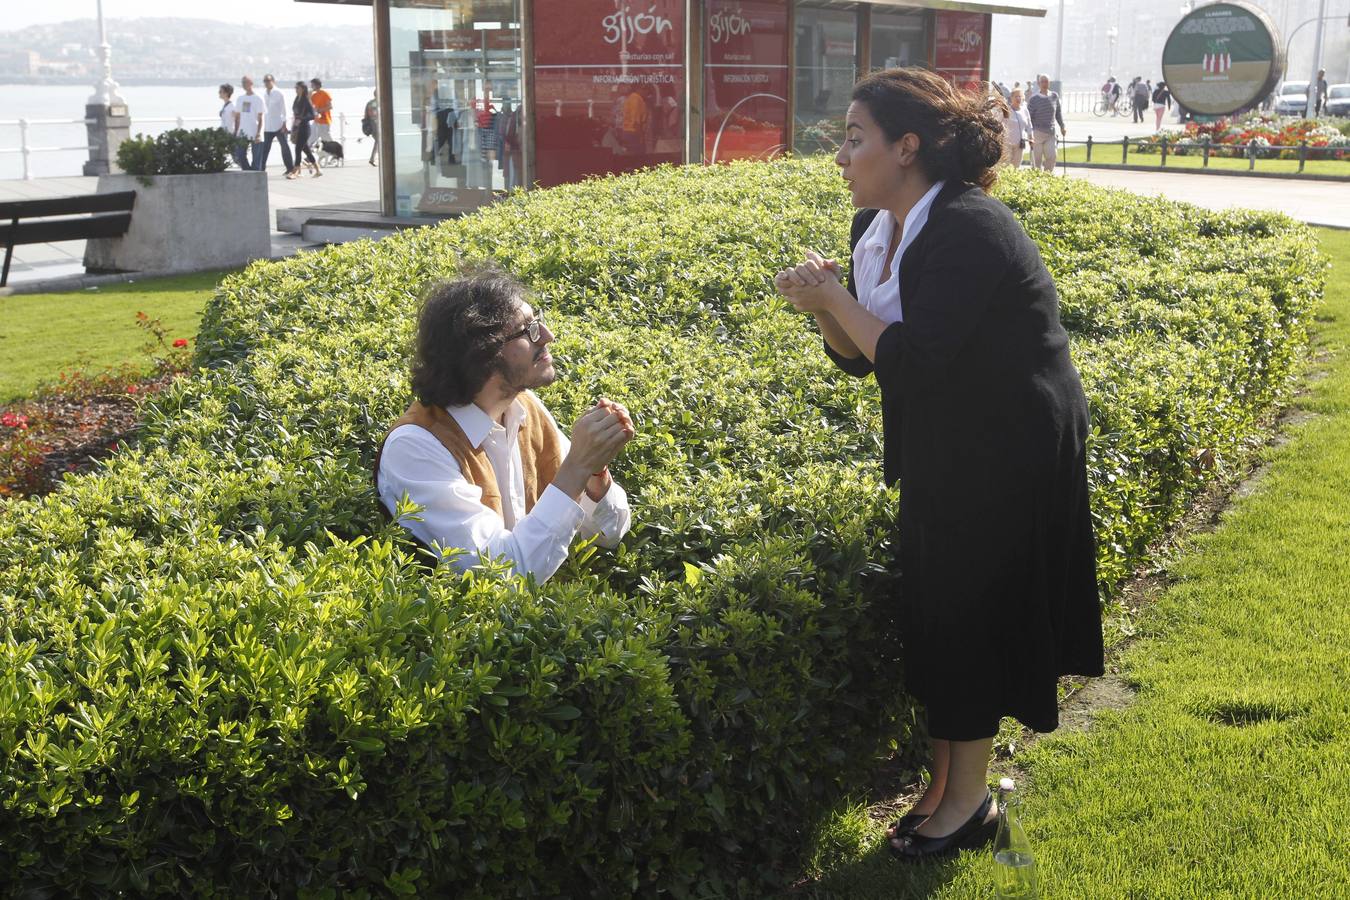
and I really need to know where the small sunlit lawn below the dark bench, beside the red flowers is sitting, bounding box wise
[0,273,221,403]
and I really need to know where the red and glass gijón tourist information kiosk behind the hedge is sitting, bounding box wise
[298,0,1045,216]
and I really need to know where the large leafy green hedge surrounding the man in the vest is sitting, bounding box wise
[0,159,1324,897]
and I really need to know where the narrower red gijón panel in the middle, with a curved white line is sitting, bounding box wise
[703,0,787,162]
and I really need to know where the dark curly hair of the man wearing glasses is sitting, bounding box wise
[412,270,525,406]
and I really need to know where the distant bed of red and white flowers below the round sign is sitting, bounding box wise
[1135,113,1350,159]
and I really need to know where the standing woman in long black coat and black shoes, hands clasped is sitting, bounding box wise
[775,69,1103,858]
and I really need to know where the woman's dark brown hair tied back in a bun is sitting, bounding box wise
[853,66,1007,190]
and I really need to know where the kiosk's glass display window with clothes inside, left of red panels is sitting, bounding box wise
[389,0,522,216]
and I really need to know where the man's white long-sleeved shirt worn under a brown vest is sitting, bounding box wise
[379,399,632,582]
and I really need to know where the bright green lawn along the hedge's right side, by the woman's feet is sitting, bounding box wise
[798,229,1350,900]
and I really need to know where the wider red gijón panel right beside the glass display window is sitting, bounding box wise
[532,0,686,188]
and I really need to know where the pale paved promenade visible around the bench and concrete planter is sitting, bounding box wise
[0,163,379,287]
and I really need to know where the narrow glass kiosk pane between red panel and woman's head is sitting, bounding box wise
[794,5,857,154]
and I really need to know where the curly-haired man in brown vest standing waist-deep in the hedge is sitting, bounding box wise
[375,271,636,582]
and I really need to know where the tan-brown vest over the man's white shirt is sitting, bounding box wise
[375,391,563,515]
